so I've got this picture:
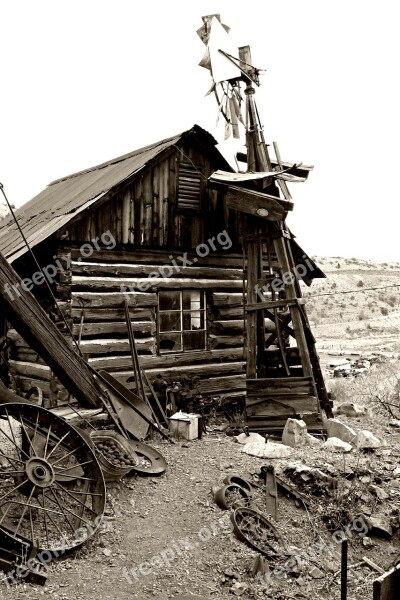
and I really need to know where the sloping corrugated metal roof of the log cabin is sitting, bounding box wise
[0,125,222,262]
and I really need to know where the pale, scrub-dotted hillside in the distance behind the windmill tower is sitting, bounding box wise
[303,257,400,354]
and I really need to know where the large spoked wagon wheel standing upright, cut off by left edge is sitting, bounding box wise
[0,403,105,553]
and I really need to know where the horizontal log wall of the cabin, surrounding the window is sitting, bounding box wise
[8,246,256,403]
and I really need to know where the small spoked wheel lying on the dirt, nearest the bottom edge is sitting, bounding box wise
[231,506,285,558]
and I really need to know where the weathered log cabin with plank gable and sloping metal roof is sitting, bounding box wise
[0,125,323,414]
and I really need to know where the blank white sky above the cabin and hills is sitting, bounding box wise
[0,0,400,260]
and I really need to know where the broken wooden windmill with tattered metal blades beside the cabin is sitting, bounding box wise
[197,15,332,433]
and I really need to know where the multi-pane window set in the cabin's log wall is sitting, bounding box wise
[158,290,206,352]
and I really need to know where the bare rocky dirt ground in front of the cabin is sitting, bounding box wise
[1,384,400,600]
